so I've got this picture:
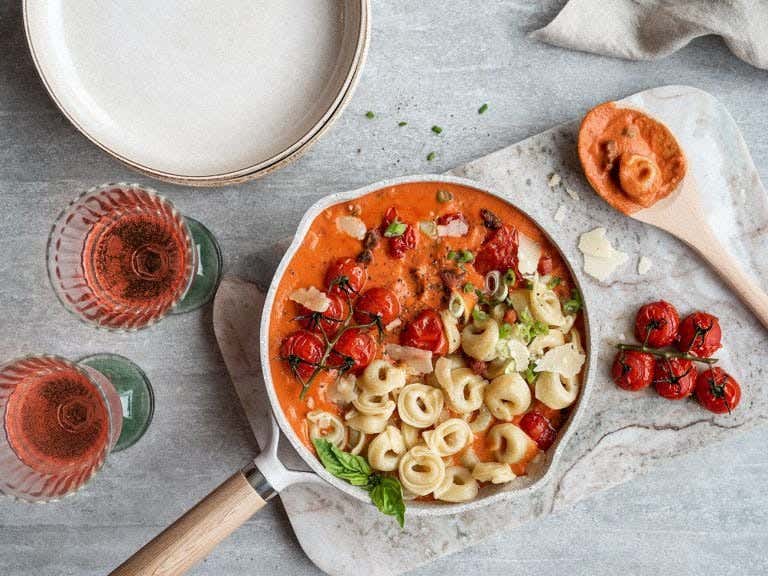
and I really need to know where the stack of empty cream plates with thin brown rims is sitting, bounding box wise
[24,0,369,185]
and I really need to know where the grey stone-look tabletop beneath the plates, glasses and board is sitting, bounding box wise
[0,0,768,576]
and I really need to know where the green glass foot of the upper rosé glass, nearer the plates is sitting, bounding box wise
[171,216,224,314]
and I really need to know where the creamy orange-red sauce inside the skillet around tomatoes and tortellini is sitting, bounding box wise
[269,182,581,475]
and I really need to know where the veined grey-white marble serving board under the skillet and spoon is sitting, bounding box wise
[222,86,768,576]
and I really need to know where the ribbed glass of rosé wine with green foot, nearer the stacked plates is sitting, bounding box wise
[47,183,222,331]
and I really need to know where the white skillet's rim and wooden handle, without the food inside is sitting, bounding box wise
[113,175,595,576]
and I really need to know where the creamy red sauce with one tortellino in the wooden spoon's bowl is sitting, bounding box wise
[578,102,686,214]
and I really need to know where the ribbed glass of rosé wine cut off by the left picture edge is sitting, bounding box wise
[0,354,154,502]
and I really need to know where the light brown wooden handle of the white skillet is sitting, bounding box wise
[111,472,266,576]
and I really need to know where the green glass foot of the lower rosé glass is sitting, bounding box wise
[78,354,155,452]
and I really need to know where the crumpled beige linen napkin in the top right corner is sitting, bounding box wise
[531,0,768,69]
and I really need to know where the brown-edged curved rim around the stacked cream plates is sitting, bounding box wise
[22,0,371,187]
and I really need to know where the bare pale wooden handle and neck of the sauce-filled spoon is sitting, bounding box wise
[629,174,768,329]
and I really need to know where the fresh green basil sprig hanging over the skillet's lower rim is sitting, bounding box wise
[312,438,405,528]
